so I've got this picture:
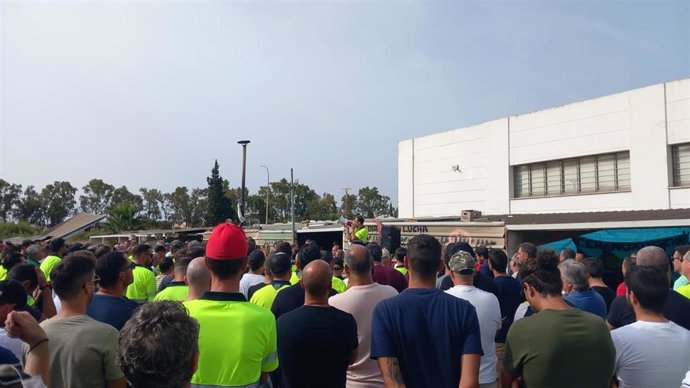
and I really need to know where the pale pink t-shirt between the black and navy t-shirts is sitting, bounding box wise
[328,283,398,388]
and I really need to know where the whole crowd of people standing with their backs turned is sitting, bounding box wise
[0,223,690,388]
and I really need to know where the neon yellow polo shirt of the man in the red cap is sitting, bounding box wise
[184,287,278,387]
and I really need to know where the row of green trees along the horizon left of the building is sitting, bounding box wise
[0,161,397,232]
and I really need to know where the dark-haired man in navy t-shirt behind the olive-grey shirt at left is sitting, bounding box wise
[86,251,139,331]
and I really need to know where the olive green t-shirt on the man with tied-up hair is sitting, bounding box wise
[503,309,616,388]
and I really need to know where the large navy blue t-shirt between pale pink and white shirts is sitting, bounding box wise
[371,288,483,387]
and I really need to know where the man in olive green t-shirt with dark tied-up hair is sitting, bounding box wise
[501,251,615,388]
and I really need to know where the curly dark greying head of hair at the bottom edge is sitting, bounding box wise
[118,301,199,388]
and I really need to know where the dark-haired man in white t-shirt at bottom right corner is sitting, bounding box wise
[611,267,690,388]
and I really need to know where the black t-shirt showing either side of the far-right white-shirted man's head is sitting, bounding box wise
[606,290,690,330]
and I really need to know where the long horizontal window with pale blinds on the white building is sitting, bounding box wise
[513,151,628,198]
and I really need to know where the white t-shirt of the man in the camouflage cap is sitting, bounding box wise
[446,286,501,384]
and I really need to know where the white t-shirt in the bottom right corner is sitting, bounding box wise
[611,321,690,388]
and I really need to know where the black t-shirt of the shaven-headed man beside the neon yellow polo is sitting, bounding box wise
[276,306,358,388]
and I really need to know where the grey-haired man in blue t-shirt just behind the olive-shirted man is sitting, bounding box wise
[558,260,606,319]
